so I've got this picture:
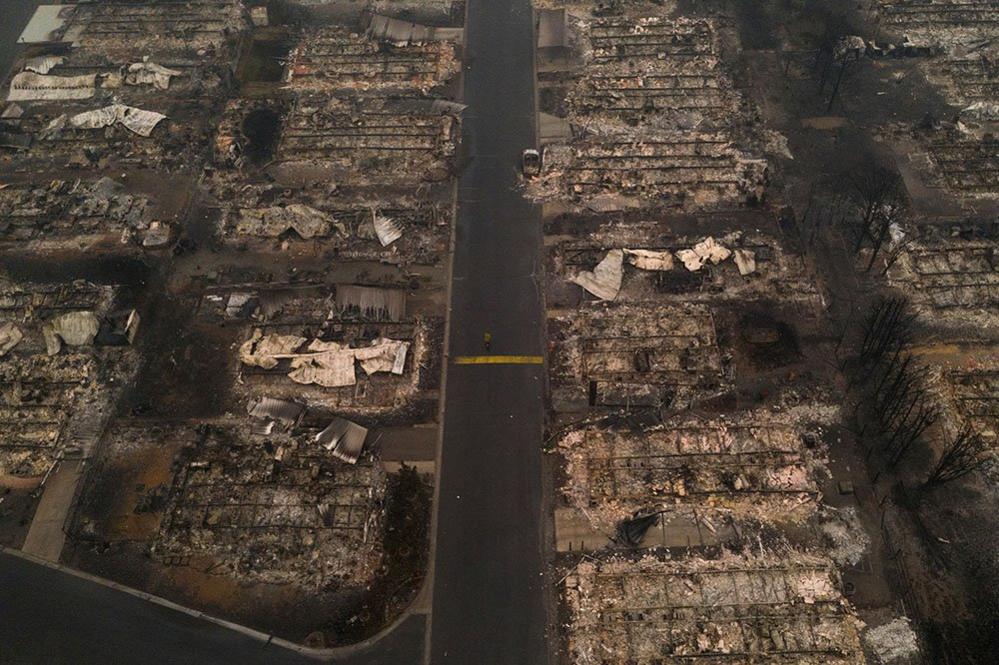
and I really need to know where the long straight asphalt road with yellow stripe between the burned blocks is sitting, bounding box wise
[430,0,548,665]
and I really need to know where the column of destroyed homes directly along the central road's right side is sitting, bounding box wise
[524,1,960,665]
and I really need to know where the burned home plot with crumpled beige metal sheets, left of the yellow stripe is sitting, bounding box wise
[202,283,442,415]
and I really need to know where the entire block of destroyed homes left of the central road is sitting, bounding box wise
[0,0,463,645]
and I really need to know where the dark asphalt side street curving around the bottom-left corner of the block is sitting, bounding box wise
[0,553,426,665]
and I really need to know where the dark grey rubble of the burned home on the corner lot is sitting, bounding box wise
[157,424,385,590]
